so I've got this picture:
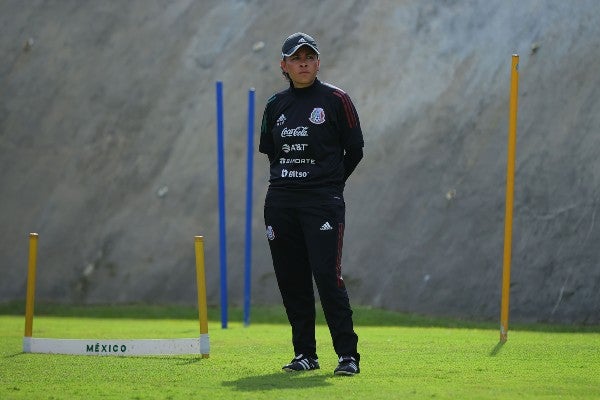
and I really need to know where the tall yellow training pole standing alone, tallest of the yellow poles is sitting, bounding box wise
[500,54,519,342]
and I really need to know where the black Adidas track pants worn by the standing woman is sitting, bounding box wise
[264,204,359,357]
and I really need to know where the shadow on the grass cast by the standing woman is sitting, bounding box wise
[222,371,331,392]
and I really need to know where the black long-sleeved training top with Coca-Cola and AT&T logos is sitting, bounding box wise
[258,79,364,206]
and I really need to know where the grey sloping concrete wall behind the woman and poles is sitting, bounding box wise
[0,0,600,323]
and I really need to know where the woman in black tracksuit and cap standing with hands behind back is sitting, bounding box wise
[259,32,364,375]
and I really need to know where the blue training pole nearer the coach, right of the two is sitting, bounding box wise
[244,88,254,326]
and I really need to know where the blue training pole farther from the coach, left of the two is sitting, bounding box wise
[216,81,227,328]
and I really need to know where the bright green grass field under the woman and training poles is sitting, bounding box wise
[0,304,600,400]
